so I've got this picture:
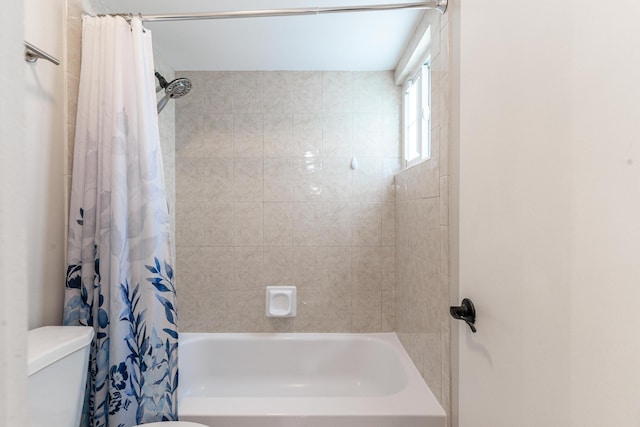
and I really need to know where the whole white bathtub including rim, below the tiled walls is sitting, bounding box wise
[178,333,446,427]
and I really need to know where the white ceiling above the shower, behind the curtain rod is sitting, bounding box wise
[102,0,424,71]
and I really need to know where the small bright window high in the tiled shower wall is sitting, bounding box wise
[403,61,431,167]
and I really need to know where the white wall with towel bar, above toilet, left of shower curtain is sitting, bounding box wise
[23,0,66,329]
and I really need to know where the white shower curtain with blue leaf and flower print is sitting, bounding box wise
[64,17,178,427]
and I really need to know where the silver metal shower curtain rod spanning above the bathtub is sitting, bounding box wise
[102,0,447,22]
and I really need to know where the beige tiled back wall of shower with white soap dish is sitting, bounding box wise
[176,71,400,332]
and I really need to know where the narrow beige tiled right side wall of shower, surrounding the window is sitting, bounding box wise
[396,13,457,422]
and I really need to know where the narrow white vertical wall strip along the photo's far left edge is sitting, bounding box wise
[0,0,27,426]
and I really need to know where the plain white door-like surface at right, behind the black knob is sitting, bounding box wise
[450,0,640,427]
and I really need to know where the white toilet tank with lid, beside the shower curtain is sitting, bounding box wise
[27,326,93,427]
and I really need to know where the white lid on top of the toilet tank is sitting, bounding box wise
[27,326,93,375]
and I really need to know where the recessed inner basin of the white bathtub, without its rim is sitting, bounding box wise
[180,334,408,397]
